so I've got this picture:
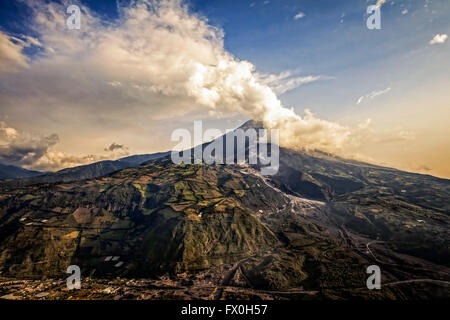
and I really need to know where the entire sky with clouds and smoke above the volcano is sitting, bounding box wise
[0,0,450,178]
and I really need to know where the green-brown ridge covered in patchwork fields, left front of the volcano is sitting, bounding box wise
[0,161,284,275]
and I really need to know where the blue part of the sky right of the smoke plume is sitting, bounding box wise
[0,0,450,117]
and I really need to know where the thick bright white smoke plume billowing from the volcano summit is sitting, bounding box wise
[65,1,358,152]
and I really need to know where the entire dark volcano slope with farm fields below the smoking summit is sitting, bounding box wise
[0,124,450,299]
